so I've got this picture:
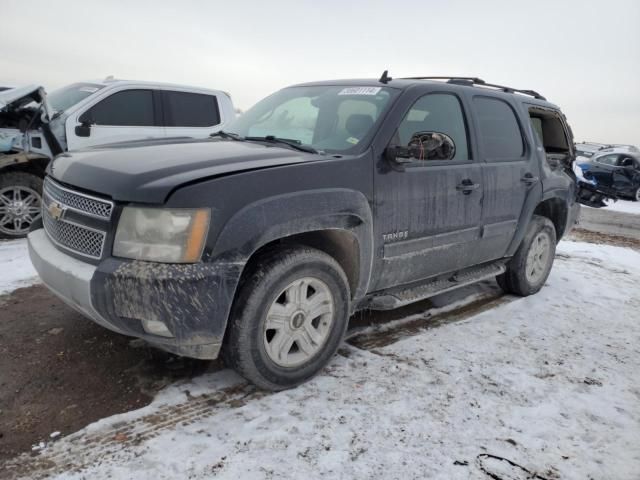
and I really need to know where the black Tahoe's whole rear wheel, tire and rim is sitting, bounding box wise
[496,215,556,297]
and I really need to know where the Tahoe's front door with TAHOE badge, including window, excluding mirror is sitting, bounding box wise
[374,89,482,290]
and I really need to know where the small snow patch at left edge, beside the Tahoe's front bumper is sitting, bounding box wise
[0,239,38,295]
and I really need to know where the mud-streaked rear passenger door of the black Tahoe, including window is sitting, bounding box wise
[471,94,540,262]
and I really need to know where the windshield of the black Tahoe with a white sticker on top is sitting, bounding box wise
[225,85,397,153]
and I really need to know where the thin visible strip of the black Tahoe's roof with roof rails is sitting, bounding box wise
[293,76,558,109]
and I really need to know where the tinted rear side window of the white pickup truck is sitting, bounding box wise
[164,92,220,127]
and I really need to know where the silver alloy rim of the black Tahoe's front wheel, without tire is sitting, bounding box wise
[263,277,335,368]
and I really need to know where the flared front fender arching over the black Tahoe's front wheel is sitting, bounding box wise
[211,189,373,299]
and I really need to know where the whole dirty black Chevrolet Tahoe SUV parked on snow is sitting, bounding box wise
[29,72,599,390]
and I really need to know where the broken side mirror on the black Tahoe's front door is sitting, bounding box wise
[385,132,456,164]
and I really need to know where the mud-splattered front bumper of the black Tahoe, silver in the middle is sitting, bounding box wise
[29,229,243,359]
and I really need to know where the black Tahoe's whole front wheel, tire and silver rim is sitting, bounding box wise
[222,246,350,390]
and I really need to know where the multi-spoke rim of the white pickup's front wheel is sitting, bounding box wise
[0,186,42,236]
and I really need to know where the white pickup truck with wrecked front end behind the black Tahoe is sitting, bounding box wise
[0,78,235,238]
